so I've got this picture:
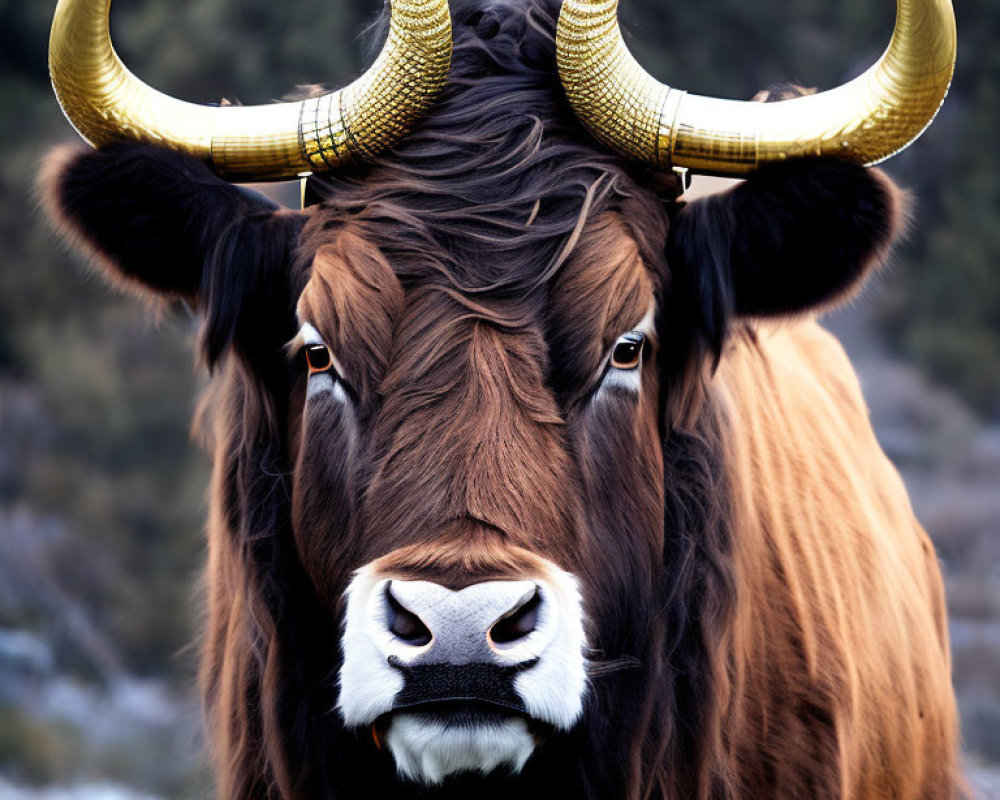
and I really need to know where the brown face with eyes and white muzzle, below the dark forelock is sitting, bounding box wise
[288,206,663,782]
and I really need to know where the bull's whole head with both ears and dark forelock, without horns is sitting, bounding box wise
[43,0,952,798]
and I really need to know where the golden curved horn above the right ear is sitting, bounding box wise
[556,0,956,175]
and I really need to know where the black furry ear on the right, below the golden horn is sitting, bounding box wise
[668,159,906,322]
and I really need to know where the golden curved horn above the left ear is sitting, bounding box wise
[49,0,451,181]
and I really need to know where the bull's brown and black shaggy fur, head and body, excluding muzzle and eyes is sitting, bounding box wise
[39,0,960,800]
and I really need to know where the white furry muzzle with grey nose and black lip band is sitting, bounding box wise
[338,565,586,783]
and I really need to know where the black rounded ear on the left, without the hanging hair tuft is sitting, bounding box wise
[40,144,288,302]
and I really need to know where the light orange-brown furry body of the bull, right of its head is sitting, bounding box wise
[713,322,957,797]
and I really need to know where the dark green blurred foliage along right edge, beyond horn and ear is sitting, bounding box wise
[881,0,1000,420]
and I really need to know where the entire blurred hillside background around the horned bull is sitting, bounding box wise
[0,0,1000,800]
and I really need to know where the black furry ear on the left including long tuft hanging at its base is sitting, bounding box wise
[40,144,305,368]
